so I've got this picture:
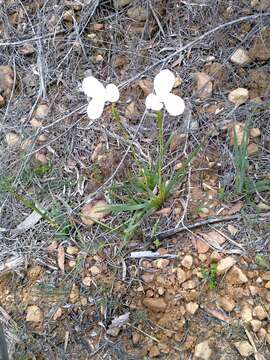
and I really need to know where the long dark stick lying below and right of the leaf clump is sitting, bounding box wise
[151,212,270,240]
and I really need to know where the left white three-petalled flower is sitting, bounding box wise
[82,76,120,120]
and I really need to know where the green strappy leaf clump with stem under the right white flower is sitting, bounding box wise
[106,109,204,241]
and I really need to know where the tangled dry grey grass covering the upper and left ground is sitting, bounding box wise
[0,0,270,359]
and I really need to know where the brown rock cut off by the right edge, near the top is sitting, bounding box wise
[248,26,270,61]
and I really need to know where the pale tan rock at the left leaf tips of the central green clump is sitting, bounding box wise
[80,200,108,226]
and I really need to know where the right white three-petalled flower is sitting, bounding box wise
[145,69,185,116]
